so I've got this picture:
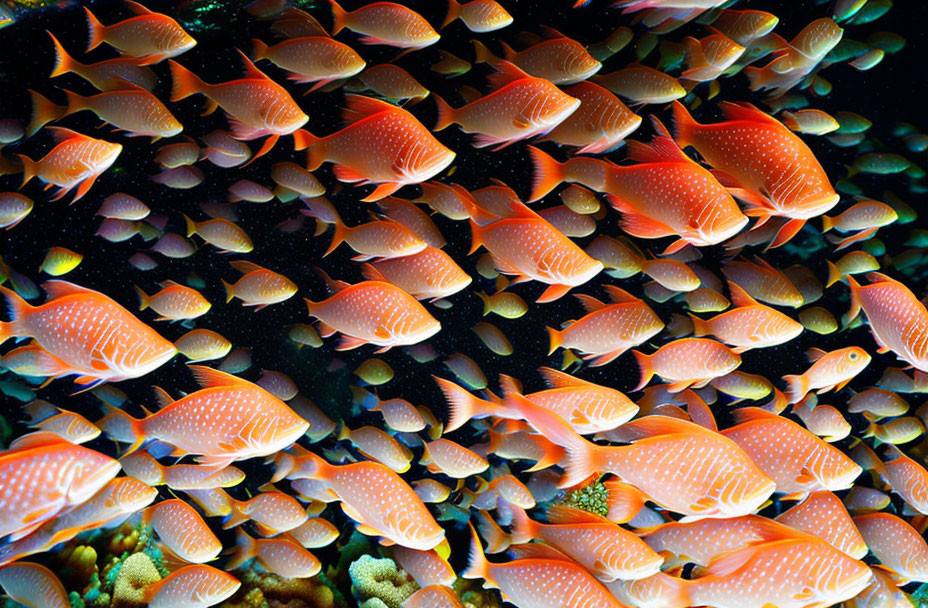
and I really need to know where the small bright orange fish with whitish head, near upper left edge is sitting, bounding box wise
[16,127,122,203]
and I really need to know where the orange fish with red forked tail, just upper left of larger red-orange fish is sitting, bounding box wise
[168,51,309,160]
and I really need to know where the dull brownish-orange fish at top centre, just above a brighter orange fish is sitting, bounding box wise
[474,27,603,85]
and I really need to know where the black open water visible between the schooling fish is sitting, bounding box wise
[0,0,928,536]
